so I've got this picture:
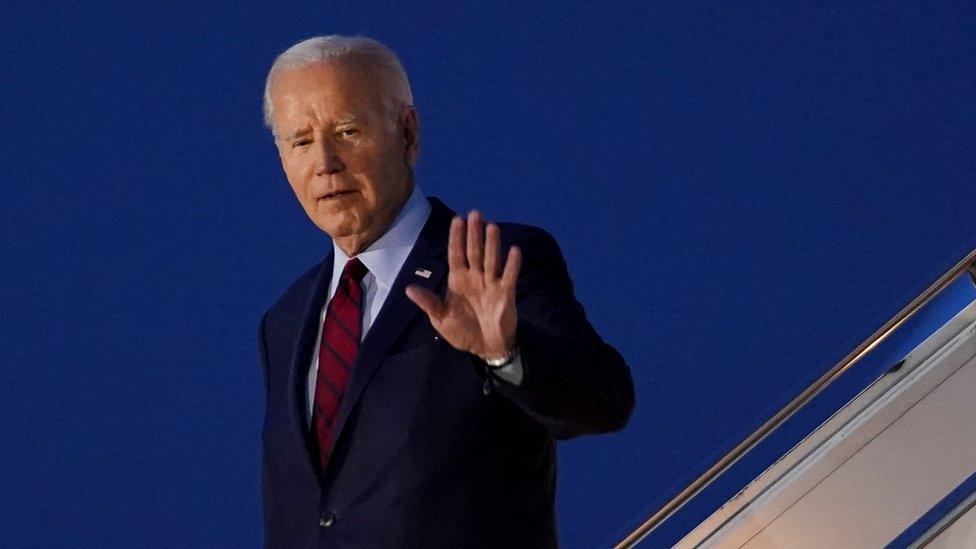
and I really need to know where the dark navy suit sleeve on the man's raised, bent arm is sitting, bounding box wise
[479,230,634,439]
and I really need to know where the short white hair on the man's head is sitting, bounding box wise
[264,34,413,134]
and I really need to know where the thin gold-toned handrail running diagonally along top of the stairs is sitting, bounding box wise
[615,250,976,549]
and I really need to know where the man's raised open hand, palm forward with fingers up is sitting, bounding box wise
[407,211,522,359]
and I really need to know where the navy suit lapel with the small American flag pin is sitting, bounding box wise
[324,197,454,463]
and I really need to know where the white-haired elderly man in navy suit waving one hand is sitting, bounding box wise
[259,36,634,547]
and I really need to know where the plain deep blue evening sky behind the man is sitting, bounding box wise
[0,2,976,547]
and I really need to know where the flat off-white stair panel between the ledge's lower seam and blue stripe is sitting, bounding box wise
[744,354,976,549]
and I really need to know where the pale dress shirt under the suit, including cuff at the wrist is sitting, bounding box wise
[306,185,522,425]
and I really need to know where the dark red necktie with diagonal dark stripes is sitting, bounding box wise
[312,257,369,471]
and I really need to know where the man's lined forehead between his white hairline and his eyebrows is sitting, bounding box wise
[271,63,383,127]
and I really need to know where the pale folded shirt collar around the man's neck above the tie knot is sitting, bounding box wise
[332,185,430,289]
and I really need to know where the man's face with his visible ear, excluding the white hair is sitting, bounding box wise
[271,63,417,255]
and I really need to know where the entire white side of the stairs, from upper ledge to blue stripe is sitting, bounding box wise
[678,303,976,548]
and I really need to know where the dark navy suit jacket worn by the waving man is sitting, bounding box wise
[259,199,634,548]
